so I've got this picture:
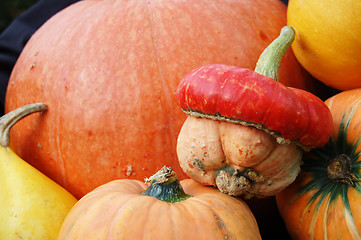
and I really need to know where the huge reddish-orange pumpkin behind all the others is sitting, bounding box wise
[5,0,308,197]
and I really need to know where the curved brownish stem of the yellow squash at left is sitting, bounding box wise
[0,103,47,148]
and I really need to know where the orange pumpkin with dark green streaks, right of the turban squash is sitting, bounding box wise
[276,89,361,240]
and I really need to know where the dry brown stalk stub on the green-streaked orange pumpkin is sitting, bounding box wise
[327,154,361,187]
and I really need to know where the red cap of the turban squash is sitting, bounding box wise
[177,27,332,149]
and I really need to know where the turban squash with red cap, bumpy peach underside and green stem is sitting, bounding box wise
[177,26,332,197]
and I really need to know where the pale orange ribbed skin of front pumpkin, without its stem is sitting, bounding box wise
[58,179,261,240]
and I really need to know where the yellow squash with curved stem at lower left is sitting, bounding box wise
[0,103,77,240]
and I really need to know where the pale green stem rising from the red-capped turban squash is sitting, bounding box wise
[255,26,295,81]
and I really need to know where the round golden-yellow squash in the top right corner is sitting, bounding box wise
[287,0,361,90]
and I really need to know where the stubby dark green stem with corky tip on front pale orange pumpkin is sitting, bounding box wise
[142,167,191,203]
